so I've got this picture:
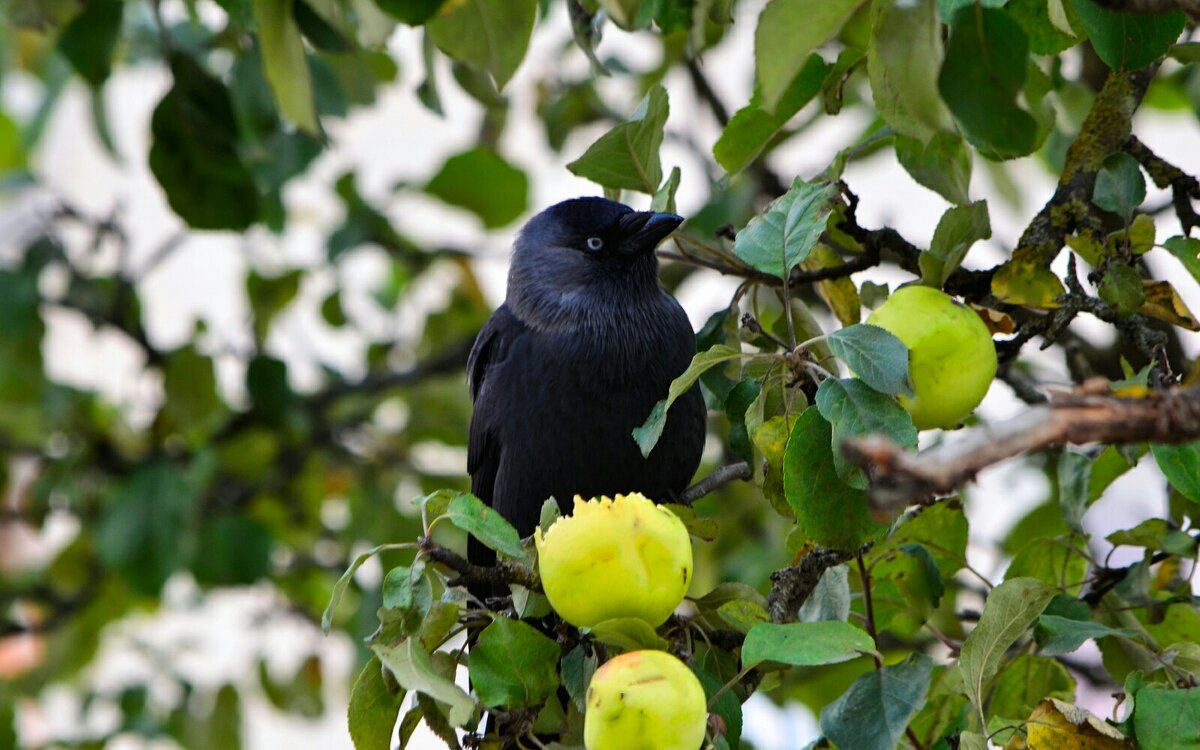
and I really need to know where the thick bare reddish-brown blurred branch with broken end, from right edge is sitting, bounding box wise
[841,383,1200,508]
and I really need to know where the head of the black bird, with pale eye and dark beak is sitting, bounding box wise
[508,198,683,319]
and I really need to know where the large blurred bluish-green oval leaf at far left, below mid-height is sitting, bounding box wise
[96,461,196,595]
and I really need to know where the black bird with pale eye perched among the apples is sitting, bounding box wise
[467,198,704,564]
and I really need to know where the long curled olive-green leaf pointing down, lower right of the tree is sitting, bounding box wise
[959,578,1055,718]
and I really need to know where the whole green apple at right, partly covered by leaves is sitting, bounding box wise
[866,286,996,430]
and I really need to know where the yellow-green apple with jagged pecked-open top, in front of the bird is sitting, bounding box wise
[534,492,691,628]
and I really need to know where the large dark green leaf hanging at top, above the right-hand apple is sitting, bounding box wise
[937,5,1038,160]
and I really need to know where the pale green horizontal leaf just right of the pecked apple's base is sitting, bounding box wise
[742,620,875,667]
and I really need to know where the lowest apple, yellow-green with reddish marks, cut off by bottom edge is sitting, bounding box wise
[583,650,708,750]
